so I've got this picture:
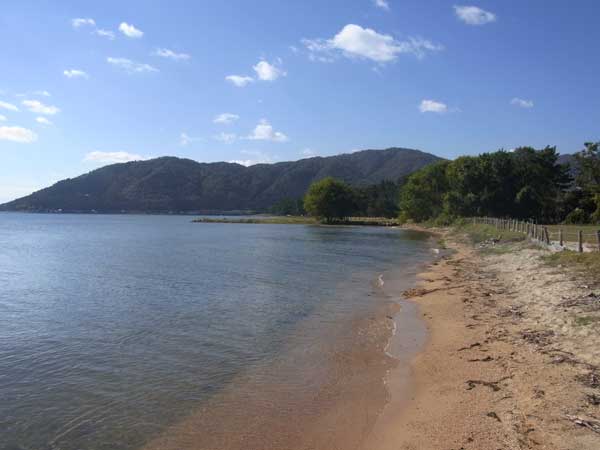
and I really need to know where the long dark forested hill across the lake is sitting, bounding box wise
[0,148,439,212]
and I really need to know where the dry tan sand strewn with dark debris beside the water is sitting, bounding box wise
[363,232,600,450]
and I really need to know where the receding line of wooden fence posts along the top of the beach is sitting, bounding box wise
[472,217,600,253]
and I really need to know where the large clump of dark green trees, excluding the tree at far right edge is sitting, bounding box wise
[399,147,571,222]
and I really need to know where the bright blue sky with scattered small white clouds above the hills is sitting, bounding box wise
[0,0,600,202]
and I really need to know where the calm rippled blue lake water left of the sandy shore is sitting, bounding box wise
[0,213,430,450]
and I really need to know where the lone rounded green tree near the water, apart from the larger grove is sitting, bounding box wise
[304,177,356,223]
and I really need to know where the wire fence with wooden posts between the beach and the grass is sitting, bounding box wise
[472,217,600,253]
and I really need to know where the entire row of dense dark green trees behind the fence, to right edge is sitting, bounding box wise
[399,143,600,223]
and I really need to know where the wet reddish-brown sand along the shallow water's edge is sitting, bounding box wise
[144,266,425,450]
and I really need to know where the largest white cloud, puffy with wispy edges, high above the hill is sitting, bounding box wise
[302,24,443,63]
